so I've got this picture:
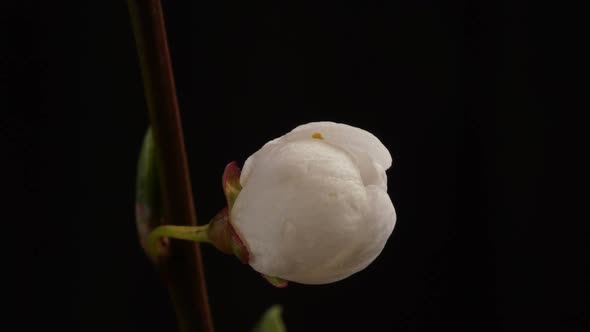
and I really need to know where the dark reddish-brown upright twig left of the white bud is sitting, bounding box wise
[128,0,213,332]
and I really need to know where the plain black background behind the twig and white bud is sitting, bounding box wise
[1,1,589,331]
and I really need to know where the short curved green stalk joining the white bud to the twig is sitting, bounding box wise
[148,225,211,258]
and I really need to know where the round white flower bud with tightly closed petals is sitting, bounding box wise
[231,122,396,284]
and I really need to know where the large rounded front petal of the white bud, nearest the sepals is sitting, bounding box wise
[231,139,370,283]
